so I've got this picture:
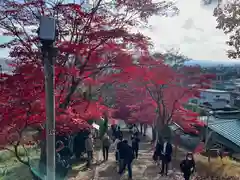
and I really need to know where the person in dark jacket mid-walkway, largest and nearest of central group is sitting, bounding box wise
[119,140,134,180]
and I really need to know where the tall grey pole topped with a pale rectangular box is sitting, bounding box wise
[38,16,57,180]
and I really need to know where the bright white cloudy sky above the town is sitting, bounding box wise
[0,0,239,69]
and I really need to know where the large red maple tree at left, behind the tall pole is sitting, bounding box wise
[0,0,177,169]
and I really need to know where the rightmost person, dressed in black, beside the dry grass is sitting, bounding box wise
[180,153,195,180]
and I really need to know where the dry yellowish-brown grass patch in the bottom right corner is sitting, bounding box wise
[195,155,240,177]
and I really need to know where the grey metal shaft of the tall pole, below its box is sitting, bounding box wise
[43,45,56,180]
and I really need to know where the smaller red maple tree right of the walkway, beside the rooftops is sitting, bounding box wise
[113,57,214,139]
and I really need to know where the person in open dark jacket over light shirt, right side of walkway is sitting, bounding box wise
[160,139,172,176]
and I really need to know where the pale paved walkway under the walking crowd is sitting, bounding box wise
[69,132,186,180]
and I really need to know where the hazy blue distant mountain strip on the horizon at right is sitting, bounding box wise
[185,60,240,67]
